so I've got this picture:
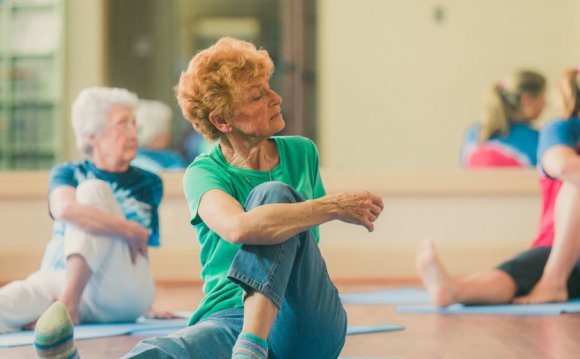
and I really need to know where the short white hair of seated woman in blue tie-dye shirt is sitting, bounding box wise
[72,87,139,154]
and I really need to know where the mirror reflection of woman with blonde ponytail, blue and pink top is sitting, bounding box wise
[461,71,546,169]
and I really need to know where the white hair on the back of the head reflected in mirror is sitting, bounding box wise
[135,100,173,147]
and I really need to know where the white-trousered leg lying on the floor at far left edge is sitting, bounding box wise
[0,270,65,334]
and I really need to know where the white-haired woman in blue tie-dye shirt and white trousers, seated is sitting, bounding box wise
[0,87,163,358]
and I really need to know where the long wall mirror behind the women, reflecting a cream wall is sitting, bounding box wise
[0,0,580,171]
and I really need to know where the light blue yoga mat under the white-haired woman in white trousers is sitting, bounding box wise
[0,319,187,348]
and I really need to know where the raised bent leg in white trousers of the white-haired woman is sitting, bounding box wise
[62,180,154,322]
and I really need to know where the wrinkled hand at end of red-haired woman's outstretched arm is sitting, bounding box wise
[336,192,384,232]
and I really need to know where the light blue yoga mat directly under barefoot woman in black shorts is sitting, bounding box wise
[396,299,580,315]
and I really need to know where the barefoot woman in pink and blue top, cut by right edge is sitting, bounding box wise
[417,70,580,306]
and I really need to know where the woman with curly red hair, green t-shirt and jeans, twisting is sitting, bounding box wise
[124,38,383,359]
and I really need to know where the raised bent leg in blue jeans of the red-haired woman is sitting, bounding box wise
[228,182,346,358]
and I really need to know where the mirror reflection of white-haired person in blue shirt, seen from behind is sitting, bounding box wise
[131,100,185,173]
